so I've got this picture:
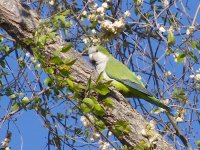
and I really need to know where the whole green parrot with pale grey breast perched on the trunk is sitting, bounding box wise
[88,46,170,111]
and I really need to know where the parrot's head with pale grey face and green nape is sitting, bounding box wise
[88,46,109,64]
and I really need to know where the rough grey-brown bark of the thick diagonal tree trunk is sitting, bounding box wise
[0,0,174,150]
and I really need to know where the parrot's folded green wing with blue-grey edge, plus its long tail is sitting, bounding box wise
[105,56,171,112]
